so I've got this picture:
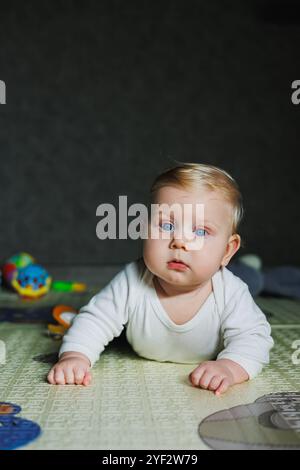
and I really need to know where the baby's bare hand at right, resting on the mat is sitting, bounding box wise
[189,359,249,395]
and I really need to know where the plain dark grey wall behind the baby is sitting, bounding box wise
[0,0,300,266]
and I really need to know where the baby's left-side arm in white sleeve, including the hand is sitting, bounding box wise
[47,263,137,385]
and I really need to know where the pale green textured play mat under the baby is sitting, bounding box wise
[0,297,300,450]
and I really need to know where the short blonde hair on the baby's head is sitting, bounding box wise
[151,162,244,234]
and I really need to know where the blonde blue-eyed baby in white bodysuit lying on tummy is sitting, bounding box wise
[48,163,273,395]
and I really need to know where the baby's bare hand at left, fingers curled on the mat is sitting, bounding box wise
[47,351,91,385]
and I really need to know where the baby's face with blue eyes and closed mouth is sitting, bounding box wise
[143,186,238,287]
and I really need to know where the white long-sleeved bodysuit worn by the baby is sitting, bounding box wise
[59,258,274,378]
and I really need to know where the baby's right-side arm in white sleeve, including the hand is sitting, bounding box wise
[189,285,274,395]
